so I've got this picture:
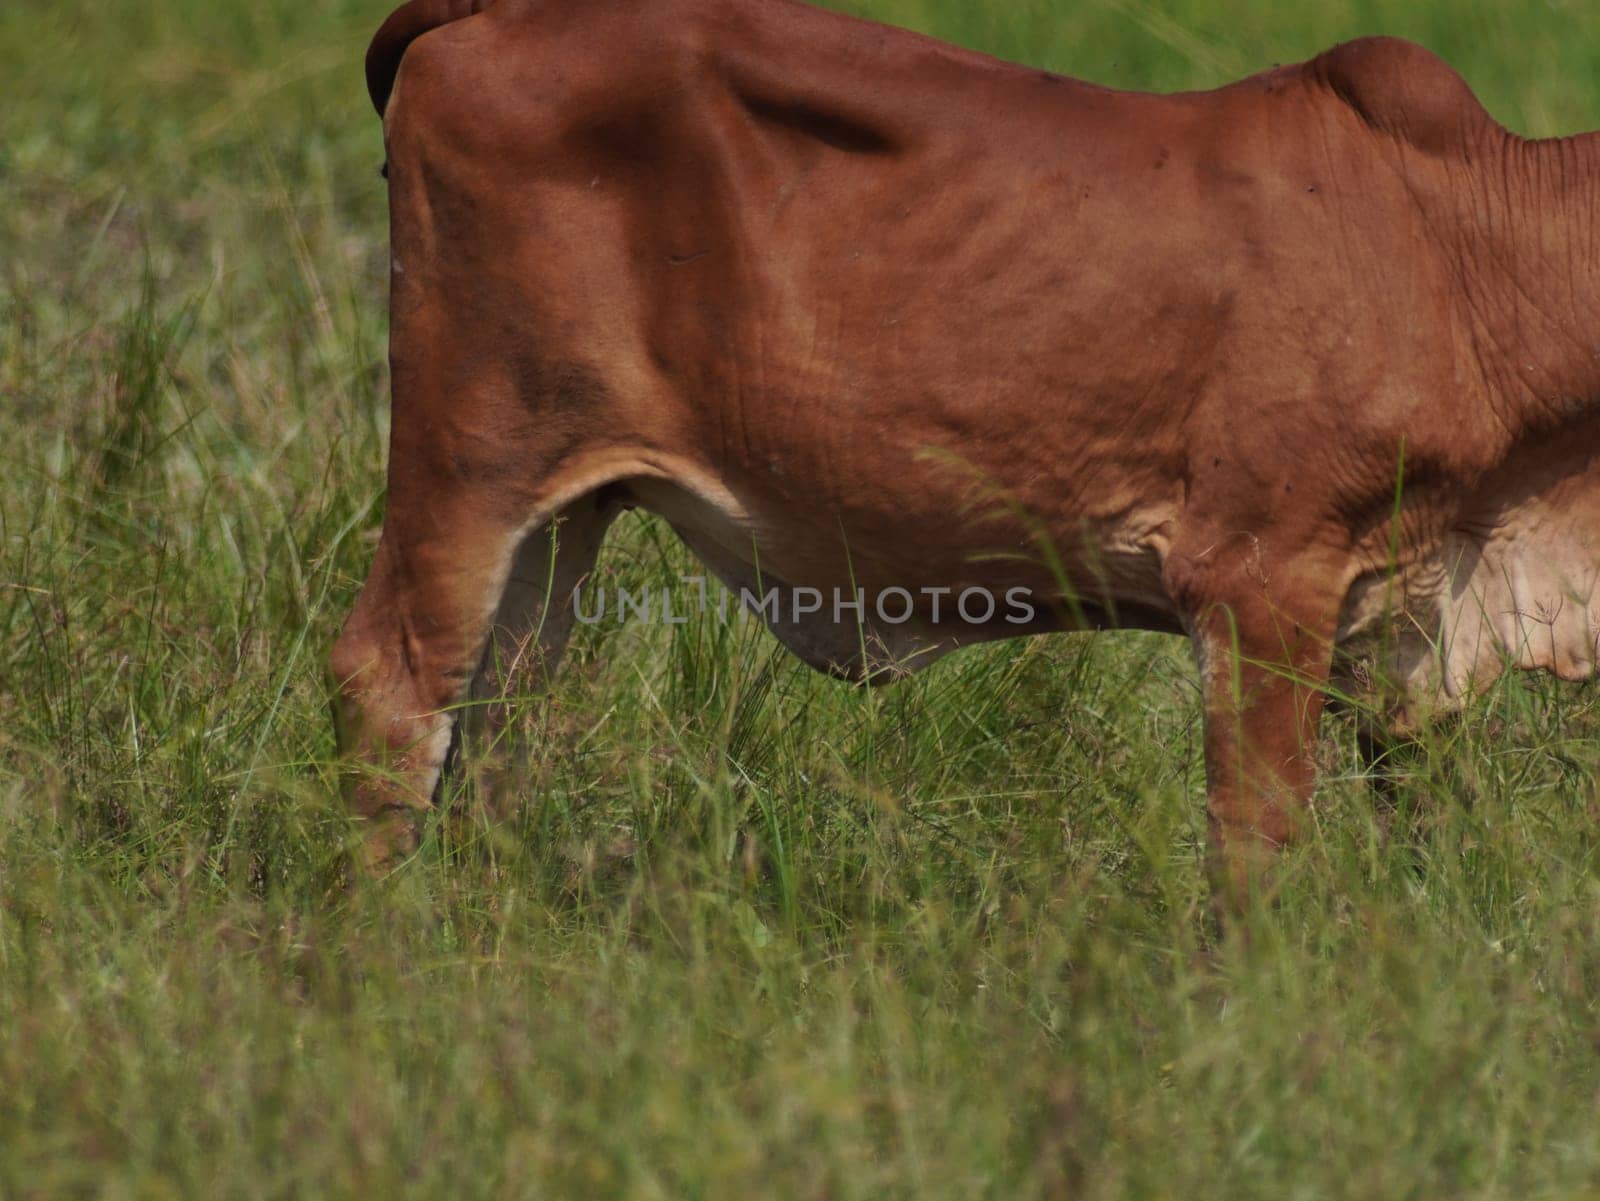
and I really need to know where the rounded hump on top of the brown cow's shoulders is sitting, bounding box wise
[1304,37,1499,157]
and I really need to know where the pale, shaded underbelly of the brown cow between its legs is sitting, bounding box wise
[626,473,1179,678]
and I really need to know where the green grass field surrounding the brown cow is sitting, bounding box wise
[0,0,1600,1201]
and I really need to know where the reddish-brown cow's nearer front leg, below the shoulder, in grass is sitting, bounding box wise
[1168,537,1341,910]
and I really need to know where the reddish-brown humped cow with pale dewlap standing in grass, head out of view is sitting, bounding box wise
[333,0,1600,889]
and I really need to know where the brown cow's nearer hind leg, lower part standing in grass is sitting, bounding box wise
[330,486,523,870]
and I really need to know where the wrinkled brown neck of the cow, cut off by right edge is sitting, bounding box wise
[1458,133,1600,425]
